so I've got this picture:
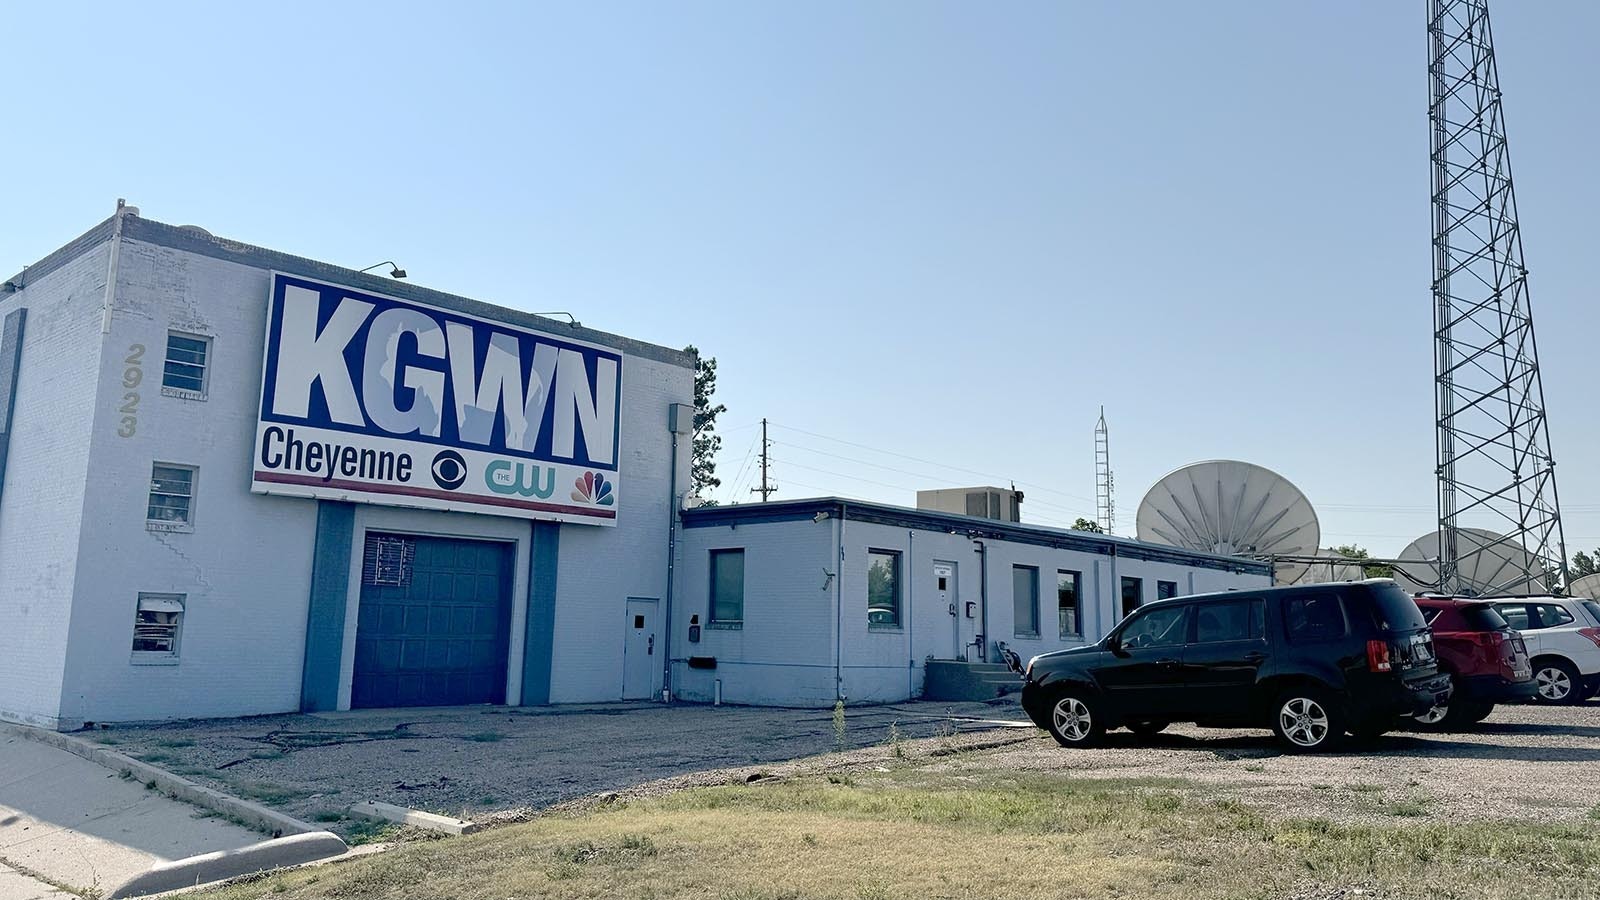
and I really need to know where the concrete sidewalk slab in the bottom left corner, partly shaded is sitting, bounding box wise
[0,733,266,900]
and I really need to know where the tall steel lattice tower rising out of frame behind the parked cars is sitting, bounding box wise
[1427,0,1566,594]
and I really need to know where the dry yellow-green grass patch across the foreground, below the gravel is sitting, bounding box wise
[187,754,1600,900]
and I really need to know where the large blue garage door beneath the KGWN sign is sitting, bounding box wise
[350,533,512,708]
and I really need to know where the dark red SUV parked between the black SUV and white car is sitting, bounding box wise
[1416,594,1539,727]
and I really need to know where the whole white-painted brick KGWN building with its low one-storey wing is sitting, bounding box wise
[0,208,1269,729]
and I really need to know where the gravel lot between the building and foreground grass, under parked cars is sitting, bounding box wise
[96,701,1600,822]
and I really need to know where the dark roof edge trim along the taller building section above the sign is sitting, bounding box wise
[0,207,694,368]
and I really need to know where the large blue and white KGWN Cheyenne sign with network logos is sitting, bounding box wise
[250,274,622,524]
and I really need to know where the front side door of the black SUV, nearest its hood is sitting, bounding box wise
[1094,605,1189,719]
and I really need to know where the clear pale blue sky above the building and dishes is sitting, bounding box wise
[9,0,1600,556]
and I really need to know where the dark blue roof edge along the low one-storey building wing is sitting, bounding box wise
[683,496,1272,577]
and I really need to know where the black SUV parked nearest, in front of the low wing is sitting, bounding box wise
[1022,578,1450,751]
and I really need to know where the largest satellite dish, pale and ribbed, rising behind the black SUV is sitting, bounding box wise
[1134,460,1322,585]
